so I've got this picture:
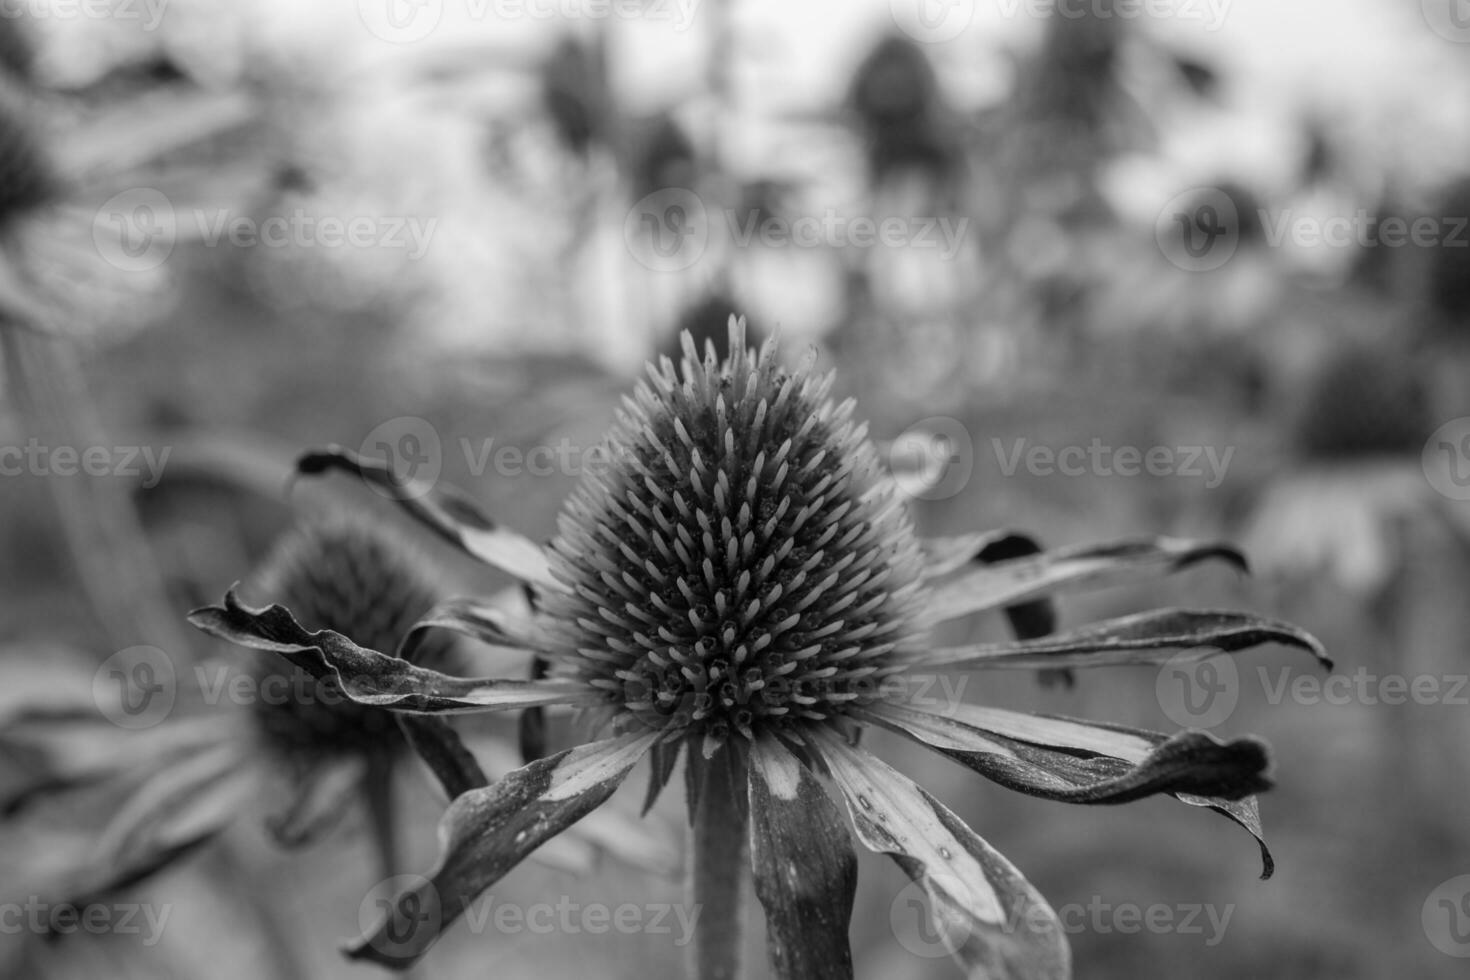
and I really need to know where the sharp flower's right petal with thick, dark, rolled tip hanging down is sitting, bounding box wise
[869,704,1276,879]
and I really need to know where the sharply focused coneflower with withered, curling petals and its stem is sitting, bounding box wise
[191,319,1324,979]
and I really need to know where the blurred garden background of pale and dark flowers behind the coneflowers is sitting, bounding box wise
[0,0,1470,980]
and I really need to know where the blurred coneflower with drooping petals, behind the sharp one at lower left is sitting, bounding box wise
[0,513,657,928]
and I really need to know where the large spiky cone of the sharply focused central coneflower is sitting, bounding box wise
[545,320,919,741]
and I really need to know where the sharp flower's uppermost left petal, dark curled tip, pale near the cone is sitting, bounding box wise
[295,445,553,586]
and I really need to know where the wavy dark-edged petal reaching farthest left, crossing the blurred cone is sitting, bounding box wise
[190,589,601,713]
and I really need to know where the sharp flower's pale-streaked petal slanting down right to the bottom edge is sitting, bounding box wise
[811,730,1072,980]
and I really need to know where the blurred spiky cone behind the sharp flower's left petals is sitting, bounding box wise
[253,516,451,754]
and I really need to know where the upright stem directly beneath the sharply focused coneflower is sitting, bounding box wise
[688,745,750,980]
